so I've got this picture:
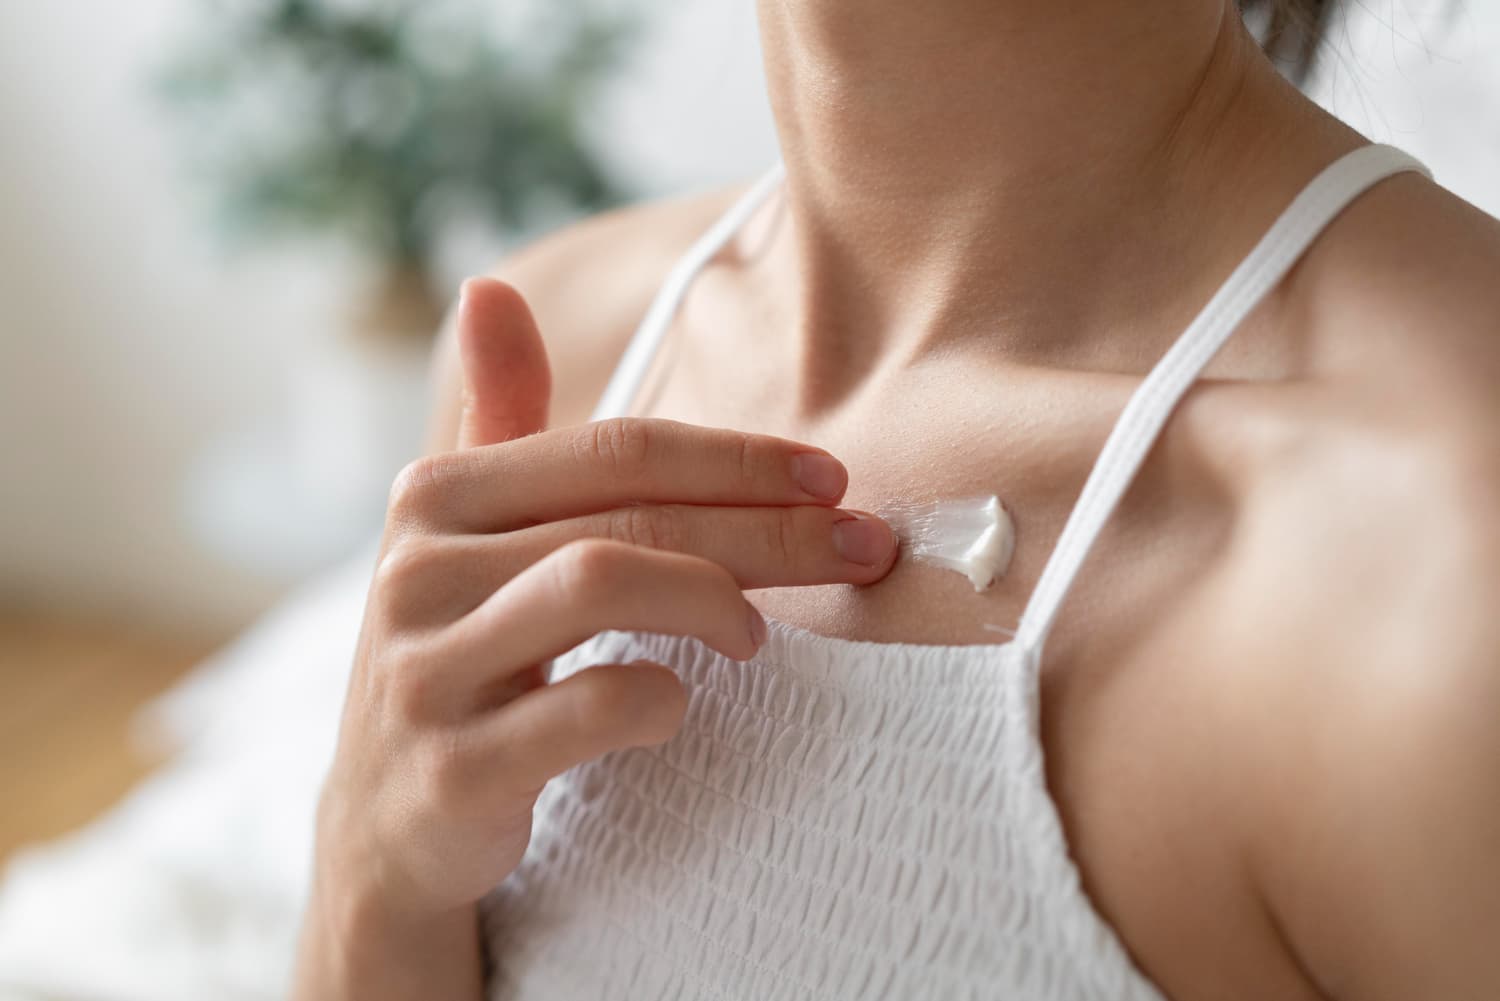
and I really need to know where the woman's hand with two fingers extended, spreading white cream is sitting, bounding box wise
[299,281,896,998]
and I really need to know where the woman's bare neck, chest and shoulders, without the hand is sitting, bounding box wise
[304,0,1500,1001]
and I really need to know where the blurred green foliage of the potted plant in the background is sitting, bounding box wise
[161,0,636,294]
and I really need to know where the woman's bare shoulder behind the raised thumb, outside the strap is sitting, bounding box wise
[432,189,740,447]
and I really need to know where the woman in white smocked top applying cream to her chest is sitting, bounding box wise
[299,0,1500,1001]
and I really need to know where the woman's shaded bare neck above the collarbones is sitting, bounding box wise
[761,0,1358,410]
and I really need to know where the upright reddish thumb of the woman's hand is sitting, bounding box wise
[458,278,552,449]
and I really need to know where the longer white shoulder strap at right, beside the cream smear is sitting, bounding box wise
[1016,144,1433,657]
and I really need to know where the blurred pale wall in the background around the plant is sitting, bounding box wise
[0,0,1500,630]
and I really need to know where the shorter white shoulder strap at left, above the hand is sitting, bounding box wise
[593,162,786,420]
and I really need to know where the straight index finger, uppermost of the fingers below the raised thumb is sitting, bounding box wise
[392,417,849,533]
